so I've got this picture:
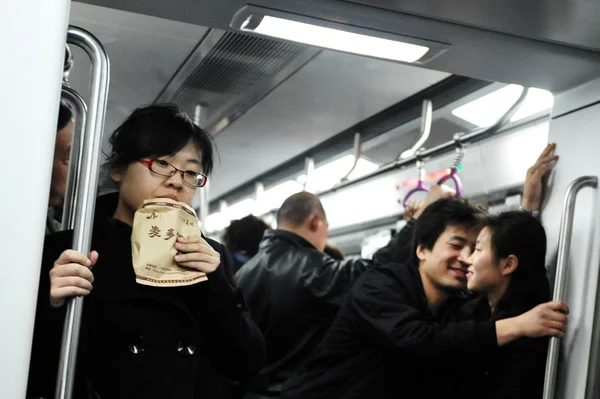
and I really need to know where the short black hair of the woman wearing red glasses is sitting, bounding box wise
[109,104,213,176]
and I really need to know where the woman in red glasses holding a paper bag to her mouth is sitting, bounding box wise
[29,105,265,399]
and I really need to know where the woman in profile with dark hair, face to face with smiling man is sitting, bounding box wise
[462,212,550,399]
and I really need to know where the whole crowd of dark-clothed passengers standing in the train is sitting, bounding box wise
[28,103,568,399]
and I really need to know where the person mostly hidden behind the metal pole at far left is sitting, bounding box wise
[46,101,74,234]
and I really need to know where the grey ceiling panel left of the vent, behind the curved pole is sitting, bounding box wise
[69,2,206,150]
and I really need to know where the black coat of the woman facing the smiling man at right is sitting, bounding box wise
[461,275,550,399]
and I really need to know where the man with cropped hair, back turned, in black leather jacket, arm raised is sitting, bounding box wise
[235,187,460,399]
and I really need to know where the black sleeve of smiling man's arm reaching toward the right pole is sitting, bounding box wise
[346,270,498,364]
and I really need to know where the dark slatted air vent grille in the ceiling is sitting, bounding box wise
[163,30,318,134]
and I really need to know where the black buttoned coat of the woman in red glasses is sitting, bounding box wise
[29,195,266,399]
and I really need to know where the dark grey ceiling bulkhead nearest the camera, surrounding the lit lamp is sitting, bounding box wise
[85,0,600,91]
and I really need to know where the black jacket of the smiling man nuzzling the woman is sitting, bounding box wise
[281,264,497,399]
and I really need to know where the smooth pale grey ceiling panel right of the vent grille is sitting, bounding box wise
[210,51,448,198]
